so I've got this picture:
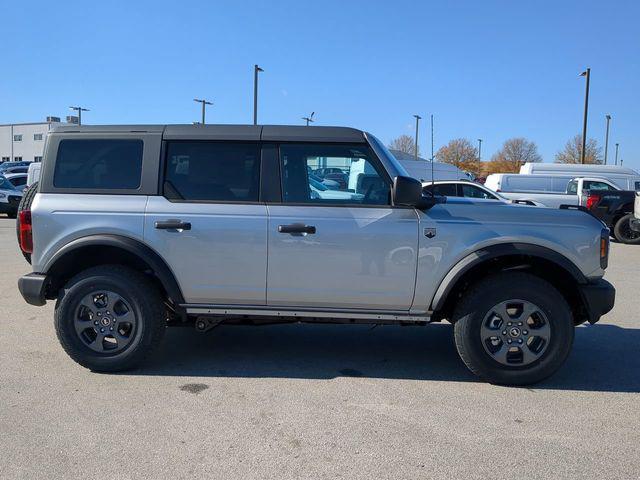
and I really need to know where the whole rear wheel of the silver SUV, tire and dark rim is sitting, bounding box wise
[55,265,166,372]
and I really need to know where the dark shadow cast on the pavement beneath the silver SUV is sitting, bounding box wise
[128,324,640,392]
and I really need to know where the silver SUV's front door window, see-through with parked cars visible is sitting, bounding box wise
[280,144,391,205]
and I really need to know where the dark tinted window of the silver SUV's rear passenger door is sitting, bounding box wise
[164,141,260,202]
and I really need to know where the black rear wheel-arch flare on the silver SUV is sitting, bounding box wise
[42,234,185,304]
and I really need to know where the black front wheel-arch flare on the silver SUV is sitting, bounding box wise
[431,243,587,311]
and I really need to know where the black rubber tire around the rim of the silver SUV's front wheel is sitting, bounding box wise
[452,272,575,385]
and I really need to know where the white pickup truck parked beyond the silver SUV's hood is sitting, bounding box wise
[490,177,620,208]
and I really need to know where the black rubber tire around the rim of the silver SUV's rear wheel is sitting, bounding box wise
[54,265,167,372]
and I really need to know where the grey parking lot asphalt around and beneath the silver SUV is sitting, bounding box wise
[0,217,640,479]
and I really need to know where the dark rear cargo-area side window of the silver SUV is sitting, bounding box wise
[53,139,142,190]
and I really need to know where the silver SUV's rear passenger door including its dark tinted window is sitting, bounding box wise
[144,140,267,305]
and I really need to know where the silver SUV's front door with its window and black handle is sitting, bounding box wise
[267,144,418,311]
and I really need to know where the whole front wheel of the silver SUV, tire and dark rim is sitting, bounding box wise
[452,272,574,385]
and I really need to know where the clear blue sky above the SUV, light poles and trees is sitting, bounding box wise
[0,0,640,168]
